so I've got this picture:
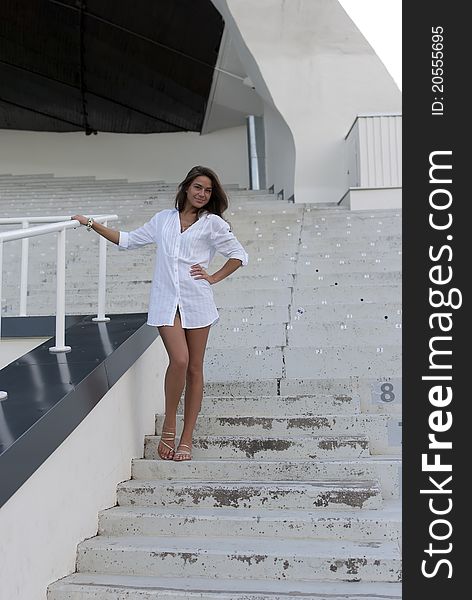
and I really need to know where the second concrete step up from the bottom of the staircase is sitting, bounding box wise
[77,536,401,582]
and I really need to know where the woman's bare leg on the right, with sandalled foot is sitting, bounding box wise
[174,325,210,460]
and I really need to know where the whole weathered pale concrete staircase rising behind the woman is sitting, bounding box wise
[0,176,401,600]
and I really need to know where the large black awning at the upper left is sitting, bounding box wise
[0,0,224,133]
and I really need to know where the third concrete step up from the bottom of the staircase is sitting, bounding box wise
[98,501,401,541]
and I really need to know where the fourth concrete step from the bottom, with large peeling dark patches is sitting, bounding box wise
[117,478,383,510]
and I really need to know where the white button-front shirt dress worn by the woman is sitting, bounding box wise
[119,208,248,329]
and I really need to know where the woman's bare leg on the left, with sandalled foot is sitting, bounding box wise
[158,311,189,459]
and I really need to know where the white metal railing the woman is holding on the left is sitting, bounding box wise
[0,215,118,352]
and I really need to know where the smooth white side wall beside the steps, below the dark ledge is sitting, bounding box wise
[0,338,167,600]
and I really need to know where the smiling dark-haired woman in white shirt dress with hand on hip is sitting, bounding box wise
[71,166,248,461]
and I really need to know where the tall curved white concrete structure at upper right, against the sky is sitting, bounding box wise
[213,0,401,202]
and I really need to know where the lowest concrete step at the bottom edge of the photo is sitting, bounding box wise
[48,573,402,600]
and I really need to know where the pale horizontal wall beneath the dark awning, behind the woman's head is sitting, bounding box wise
[0,127,249,187]
